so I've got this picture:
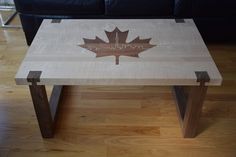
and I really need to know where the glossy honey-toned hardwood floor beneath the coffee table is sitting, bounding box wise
[0,15,236,157]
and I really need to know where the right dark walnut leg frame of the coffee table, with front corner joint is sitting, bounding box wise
[173,71,210,138]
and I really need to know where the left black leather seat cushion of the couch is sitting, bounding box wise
[14,0,104,15]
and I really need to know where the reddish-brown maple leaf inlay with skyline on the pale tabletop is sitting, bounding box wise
[79,27,156,64]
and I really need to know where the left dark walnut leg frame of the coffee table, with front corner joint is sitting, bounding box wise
[27,71,63,138]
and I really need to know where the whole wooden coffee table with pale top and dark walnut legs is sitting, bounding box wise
[15,19,222,138]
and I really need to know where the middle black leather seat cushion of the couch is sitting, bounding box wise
[105,0,174,16]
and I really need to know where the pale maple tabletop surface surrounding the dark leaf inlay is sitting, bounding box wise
[16,19,222,85]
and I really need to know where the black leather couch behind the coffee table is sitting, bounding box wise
[14,0,236,45]
